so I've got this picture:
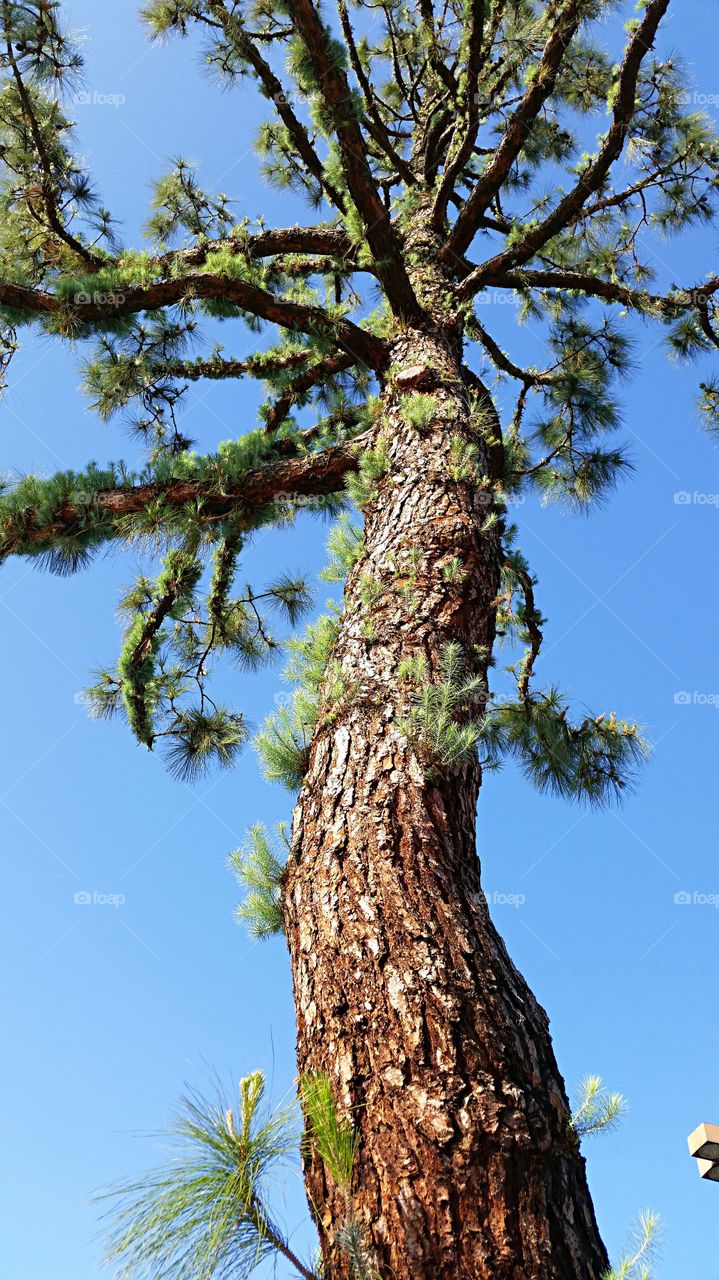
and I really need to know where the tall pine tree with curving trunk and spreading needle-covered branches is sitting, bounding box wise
[0,0,719,1280]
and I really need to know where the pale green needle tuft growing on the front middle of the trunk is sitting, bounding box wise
[398,644,486,768]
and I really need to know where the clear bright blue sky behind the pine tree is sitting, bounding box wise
[0,0,719,1280]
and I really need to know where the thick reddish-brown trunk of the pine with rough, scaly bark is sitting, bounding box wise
[285,312,608,1280]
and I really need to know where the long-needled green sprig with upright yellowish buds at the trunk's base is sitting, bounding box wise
[100,1071,312,1280]
